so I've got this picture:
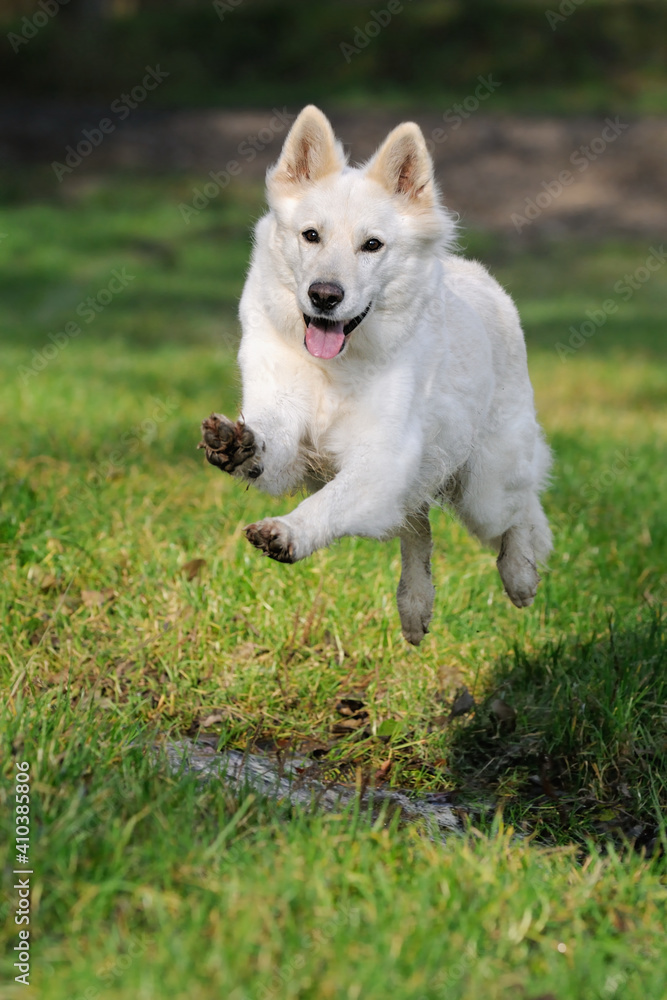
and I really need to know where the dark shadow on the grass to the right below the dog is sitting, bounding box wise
[450,609,667,853]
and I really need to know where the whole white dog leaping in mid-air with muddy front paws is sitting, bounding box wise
[202,106,551,645]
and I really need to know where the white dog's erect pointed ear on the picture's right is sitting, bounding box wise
[366,122,435,205]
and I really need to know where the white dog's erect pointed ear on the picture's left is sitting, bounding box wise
[266,104,345,187]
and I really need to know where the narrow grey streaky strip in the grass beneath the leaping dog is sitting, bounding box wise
[162,737,463,837]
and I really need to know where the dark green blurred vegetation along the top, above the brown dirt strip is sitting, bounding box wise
[0,0,667,113]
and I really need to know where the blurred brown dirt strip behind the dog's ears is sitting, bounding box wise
[0,105,667,241]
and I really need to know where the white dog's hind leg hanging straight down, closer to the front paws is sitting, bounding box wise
[396,508,435,646]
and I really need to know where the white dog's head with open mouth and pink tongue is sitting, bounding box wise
[267,105,454,359]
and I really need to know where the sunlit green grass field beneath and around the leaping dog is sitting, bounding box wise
[0,177,667,1000]
